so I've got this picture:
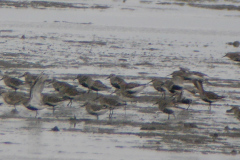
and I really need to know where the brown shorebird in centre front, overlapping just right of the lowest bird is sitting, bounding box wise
[95,96,126,118]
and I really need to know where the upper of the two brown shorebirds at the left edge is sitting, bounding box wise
[1,75,24,92]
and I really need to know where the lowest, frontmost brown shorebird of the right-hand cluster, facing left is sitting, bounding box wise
[155,99,176,119]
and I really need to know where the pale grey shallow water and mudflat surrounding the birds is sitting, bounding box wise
[0,0,240,159]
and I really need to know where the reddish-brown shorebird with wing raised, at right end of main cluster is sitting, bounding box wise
[193,80,225,110]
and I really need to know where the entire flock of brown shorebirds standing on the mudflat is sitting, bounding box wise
[1,53,240,119]
